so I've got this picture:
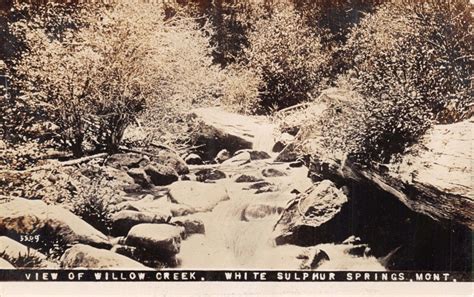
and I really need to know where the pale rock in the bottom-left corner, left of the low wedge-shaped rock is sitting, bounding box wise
[0,236,58,268]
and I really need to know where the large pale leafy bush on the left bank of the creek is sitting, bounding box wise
[13,2,208,155]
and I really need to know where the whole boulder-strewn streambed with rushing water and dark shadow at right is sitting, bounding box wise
[0,104,472,271]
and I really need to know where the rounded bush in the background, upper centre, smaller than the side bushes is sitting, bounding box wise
[244,9,328,112]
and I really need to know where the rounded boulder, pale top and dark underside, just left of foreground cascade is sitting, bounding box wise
[125,224,184,255]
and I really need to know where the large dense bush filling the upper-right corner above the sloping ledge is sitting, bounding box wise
[334,0,474,163]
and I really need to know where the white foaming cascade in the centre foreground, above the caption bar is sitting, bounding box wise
[179,180,302,269]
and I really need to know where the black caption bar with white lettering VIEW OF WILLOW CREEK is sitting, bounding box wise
[0,269,472,282]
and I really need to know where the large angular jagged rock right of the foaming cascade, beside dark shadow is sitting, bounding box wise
[274,180,348,246]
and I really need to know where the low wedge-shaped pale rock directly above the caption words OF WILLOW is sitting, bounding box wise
[60,244,149,270]
